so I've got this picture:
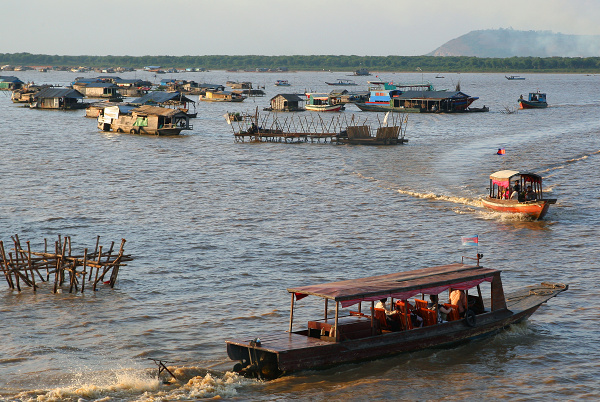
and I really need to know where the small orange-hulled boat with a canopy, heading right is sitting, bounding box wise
[481,170,556,220]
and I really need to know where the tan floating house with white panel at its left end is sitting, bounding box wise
[98,105,193,135]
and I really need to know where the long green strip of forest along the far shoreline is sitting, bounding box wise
[0,53,600,73]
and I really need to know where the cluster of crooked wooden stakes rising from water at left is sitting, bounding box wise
[0,235,132,293]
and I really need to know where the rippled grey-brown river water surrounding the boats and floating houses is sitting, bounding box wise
[0,71,600,401]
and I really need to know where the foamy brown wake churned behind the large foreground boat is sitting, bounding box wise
[15,367,254,402]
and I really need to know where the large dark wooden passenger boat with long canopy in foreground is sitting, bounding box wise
[226,260,568,379]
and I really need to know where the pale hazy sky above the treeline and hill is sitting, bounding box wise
[0,0,600,56]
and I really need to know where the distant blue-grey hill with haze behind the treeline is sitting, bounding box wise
[427,29,600,57]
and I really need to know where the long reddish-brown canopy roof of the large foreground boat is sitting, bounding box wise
[288,264,494,307]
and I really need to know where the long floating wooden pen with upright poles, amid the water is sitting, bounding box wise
[228,109,408,145]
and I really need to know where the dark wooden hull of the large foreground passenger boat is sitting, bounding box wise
[227,284,568,379]
